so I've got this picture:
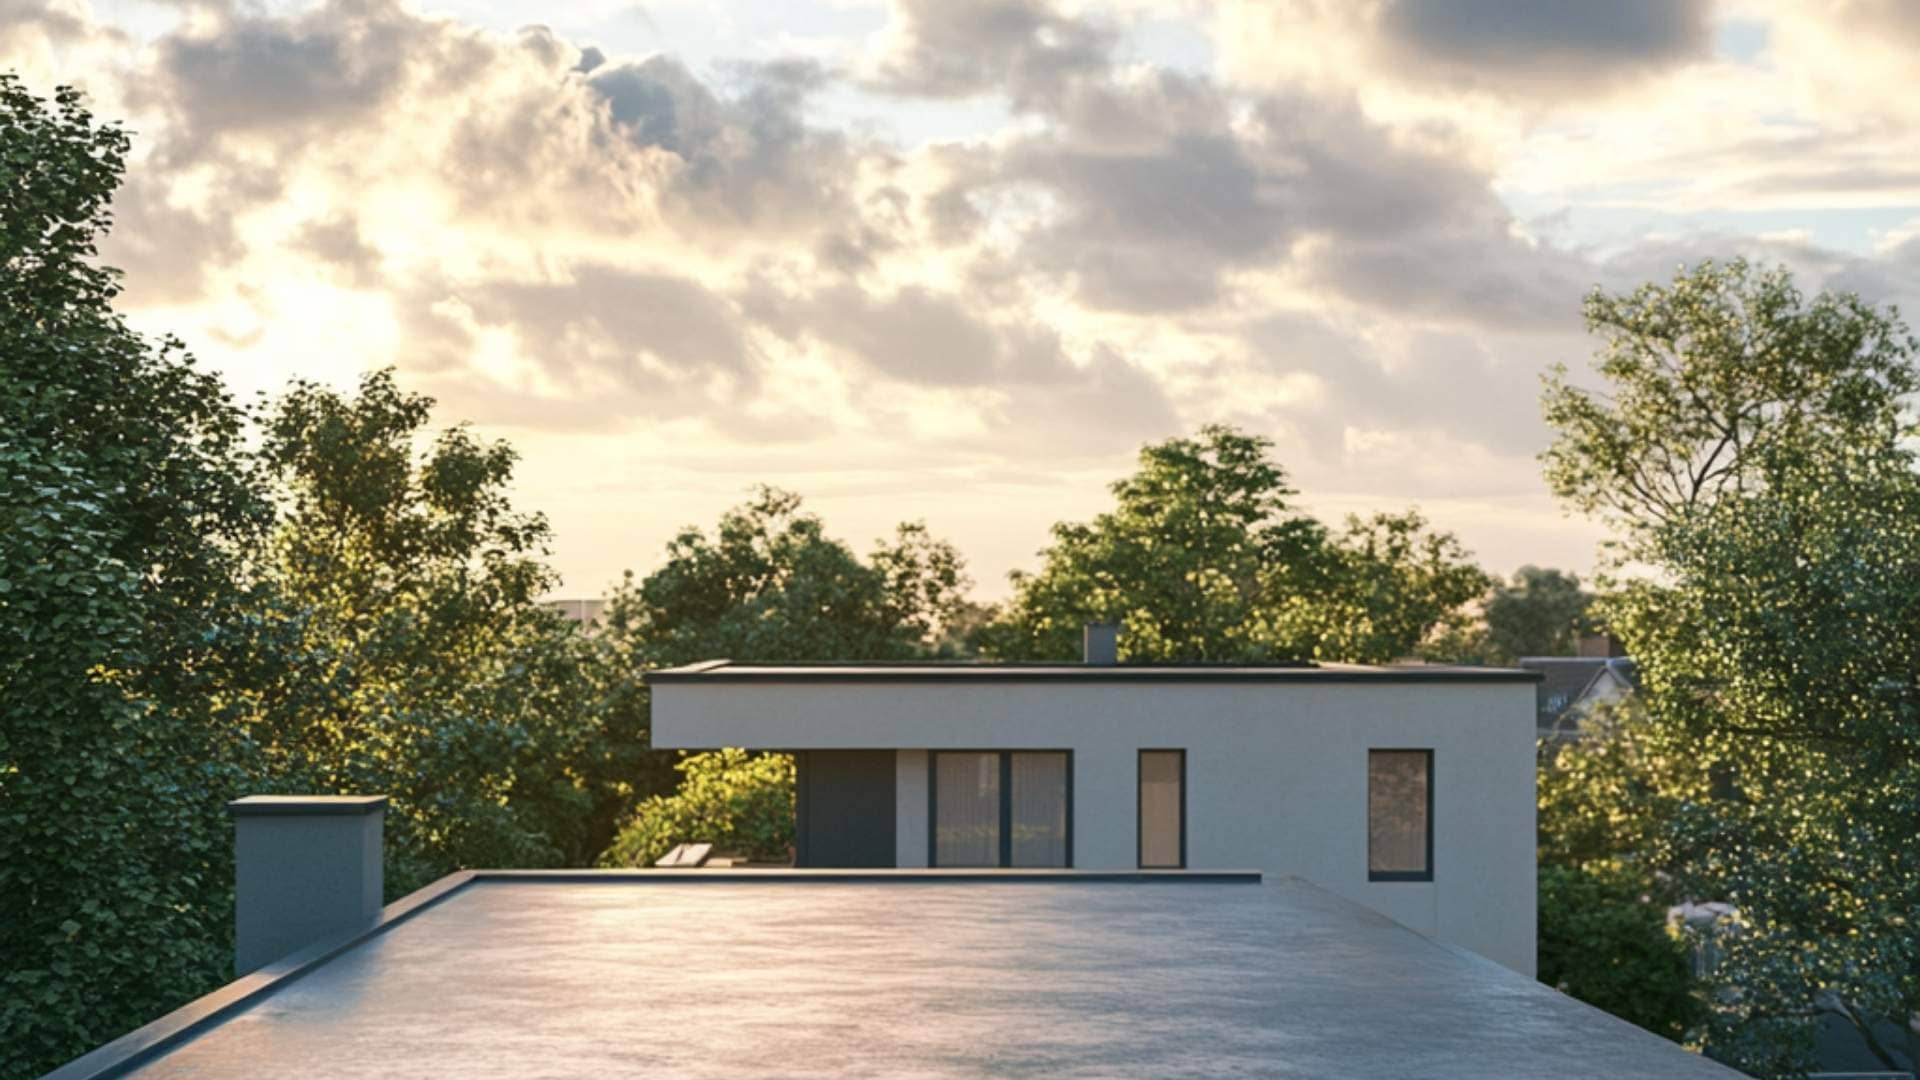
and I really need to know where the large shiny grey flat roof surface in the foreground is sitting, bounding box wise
[69,871,1738,1080]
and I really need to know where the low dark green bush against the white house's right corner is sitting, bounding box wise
[1540,865,1703,1042]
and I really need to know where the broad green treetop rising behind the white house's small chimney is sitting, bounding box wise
[983,427,1486,661]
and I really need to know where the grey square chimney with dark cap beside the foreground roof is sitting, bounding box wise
[227,796,386,978]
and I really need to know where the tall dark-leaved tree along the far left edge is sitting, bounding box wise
[0,75,267,1076]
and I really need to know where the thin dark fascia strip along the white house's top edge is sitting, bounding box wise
[645,665,1544,684]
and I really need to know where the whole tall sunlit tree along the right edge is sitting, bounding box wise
[1546,263,1920,1074]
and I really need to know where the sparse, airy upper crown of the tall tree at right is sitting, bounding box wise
[1542,259,1920,541]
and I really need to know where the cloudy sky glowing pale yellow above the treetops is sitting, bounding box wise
[0,0,1920,598]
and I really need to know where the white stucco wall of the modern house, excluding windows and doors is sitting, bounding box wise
[653,680,1534,974]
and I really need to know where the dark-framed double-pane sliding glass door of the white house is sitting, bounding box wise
[927,749,1073,867]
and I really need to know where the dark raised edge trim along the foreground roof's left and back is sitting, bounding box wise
[40,867,1261,1080]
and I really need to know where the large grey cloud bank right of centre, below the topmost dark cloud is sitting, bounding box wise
[937,62,1590,327]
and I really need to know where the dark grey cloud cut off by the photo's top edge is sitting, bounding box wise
[1379,0,1713,96]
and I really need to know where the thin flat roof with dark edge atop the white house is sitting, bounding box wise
[647,659,1542,684]
